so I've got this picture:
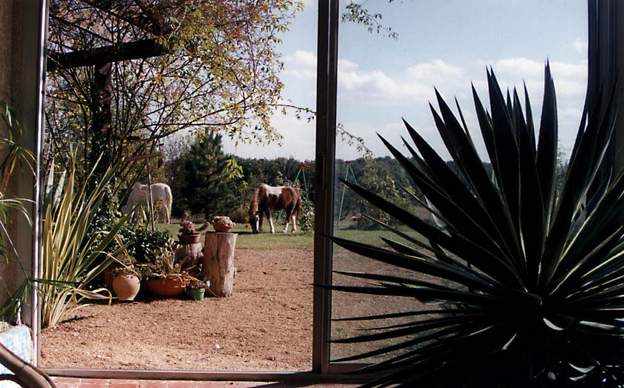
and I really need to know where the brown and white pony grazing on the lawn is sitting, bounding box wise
[249,183,301,233]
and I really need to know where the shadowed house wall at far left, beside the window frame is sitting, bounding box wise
[0,0,46,340]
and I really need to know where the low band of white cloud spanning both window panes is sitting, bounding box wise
[276,50,587,159]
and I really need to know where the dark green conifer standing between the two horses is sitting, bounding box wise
[172,132,242,219]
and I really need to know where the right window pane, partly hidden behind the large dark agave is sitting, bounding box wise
[331,0,587,360]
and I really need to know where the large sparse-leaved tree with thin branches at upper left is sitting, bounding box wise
[46,0,302,173]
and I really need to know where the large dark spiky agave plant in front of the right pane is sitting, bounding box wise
[333,64,624,387]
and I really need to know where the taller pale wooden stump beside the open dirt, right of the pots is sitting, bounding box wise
[202,232,238,297]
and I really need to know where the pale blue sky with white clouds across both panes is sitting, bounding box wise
[225,0,587,160]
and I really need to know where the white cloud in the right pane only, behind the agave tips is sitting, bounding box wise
[338,57,587,156]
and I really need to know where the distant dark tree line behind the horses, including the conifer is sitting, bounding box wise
[153,132,414,227]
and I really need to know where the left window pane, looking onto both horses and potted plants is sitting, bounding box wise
[42,0,317,371]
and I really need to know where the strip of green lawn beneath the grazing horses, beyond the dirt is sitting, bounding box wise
[156,224,424,249]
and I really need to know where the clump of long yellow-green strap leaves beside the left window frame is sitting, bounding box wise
[40,158,126,327]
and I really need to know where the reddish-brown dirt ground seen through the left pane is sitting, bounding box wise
[41,249,313,371]
